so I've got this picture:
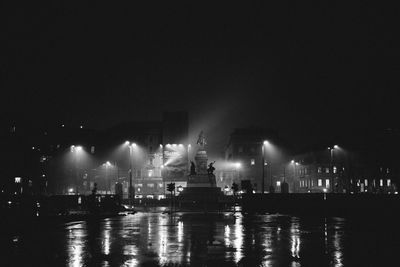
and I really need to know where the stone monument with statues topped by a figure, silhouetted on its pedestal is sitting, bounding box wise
[180,131,223,210]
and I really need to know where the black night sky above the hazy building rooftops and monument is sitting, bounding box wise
[0,1,400,156]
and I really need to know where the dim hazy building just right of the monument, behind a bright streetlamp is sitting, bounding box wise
[222,127,287,192]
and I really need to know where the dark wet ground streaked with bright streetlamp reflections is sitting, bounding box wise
[0,212,400,267]
